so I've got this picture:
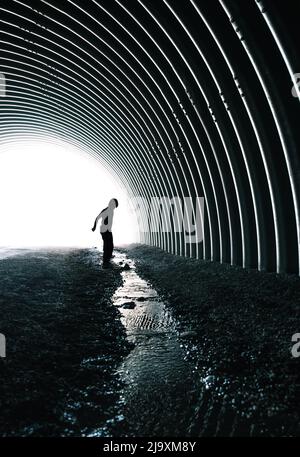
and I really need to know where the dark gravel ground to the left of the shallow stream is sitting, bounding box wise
[0,249,130,436]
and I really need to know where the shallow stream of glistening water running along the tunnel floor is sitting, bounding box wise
[106,253,200,436]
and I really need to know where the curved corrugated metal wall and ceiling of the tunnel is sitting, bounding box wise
[0,0,300,273]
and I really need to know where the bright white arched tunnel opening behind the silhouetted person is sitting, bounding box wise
[0,140,137,247]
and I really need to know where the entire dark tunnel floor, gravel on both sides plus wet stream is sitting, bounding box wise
[0,247,300,436]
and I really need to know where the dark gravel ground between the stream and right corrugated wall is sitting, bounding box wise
[126,242,300,436]
